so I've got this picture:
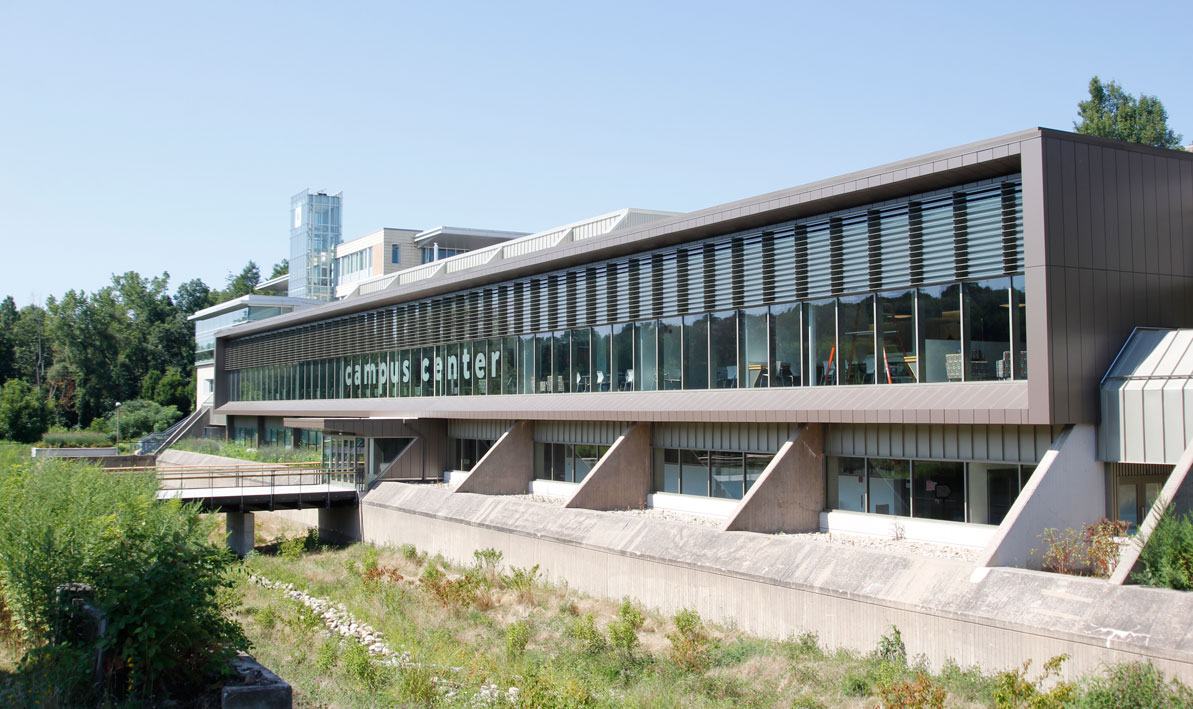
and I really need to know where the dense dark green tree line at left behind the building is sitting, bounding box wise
[0,256,286,440]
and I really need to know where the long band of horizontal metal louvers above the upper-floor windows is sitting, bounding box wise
[223,175,1024,372]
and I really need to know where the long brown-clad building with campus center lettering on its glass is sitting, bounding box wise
[214,129,1193,545]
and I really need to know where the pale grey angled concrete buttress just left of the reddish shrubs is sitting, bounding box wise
[972,424,1106,570]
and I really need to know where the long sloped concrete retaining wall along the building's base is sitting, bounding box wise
[348,483,1193,683]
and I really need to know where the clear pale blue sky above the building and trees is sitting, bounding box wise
[0,1,1193,306]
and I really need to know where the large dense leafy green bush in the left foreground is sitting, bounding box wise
[0,461,248,696]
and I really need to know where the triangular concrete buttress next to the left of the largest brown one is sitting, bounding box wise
[564,423,650,510]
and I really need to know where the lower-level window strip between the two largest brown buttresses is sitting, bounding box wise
[650,448,774,500]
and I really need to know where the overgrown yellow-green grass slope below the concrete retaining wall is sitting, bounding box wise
[241,532,993,707]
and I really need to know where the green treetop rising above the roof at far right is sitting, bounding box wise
[1073,76,1181,148]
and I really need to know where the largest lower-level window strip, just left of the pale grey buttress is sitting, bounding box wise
[826,456,1036,524]
